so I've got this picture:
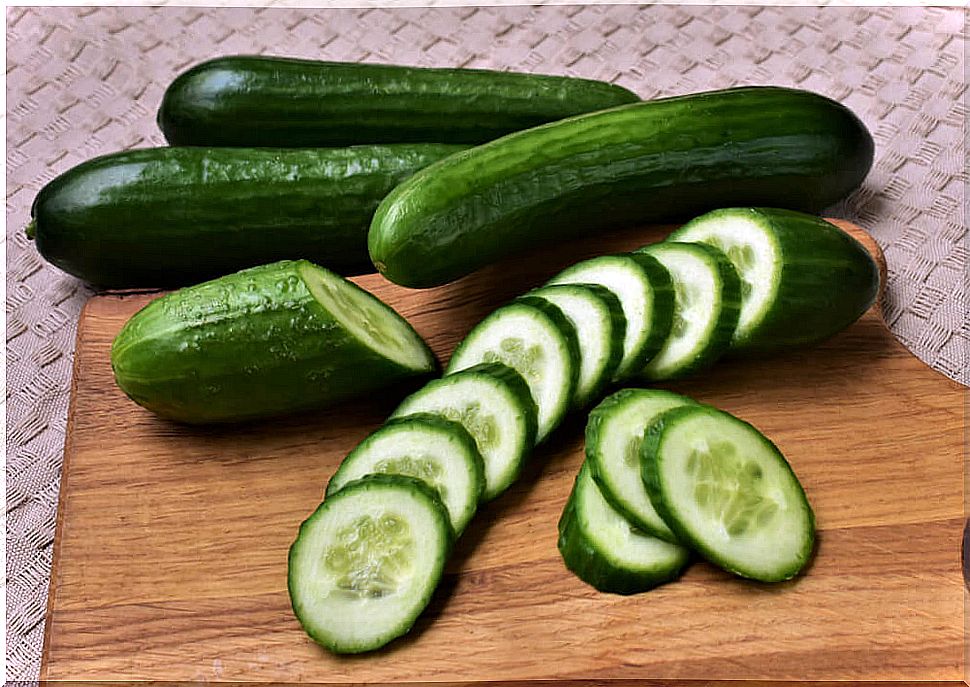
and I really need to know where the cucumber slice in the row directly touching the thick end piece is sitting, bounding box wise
[637,243,741,380]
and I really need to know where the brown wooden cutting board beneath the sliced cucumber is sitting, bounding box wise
[42,227,966,684]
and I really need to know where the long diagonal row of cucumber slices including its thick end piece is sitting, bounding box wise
[289,209,878,652]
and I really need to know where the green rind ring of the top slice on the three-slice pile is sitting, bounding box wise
[640,403,815,582]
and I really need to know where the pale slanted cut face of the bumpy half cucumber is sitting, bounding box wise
[296,264,433,369]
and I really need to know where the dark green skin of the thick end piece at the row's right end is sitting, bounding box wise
[667,208,879,354]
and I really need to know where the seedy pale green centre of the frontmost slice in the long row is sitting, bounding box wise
[323,511,415,598]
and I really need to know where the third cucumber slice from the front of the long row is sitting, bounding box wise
[391,363,536,500]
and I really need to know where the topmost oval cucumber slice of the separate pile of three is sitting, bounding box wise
[641,405,815,582]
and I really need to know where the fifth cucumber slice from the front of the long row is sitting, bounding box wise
[520,284,626,408]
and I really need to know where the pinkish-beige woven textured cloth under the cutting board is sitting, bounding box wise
[6,5,970,680]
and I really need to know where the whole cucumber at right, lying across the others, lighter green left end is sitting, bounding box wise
[368,87,873,287]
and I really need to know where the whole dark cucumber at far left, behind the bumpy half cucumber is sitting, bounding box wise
[30,144,464,288]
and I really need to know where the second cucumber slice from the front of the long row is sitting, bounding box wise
[327,414,485,534]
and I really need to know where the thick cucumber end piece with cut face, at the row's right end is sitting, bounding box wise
[667,208,879,352]
